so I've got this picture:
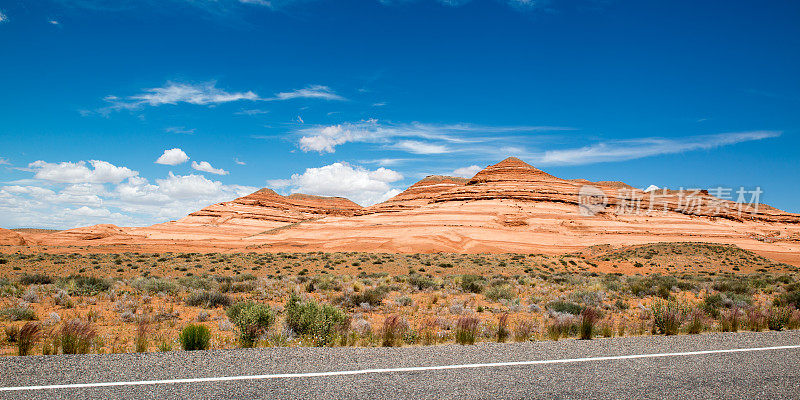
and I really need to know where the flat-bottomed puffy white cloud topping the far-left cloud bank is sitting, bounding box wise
[28,160,139,183]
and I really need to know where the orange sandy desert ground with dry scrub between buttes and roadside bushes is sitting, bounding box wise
[0,243,800,355]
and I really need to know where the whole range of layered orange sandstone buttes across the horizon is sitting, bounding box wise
[10,158,800,265]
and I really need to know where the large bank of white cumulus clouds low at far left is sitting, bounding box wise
[0,161,258,228]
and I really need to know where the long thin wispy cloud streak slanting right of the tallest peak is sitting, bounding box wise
[531,131,781,165]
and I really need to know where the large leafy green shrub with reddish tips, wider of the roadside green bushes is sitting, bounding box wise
[284,294,349,346]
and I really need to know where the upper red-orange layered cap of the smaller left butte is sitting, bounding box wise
[178,188,361,225]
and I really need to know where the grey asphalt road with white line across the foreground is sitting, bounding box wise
[0,331,800,399]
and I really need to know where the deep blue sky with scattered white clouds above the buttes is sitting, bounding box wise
[0,0,800,228]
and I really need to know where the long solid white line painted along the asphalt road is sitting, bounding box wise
[0,345,800,392]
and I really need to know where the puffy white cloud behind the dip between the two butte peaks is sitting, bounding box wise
[268,162,403,206]
